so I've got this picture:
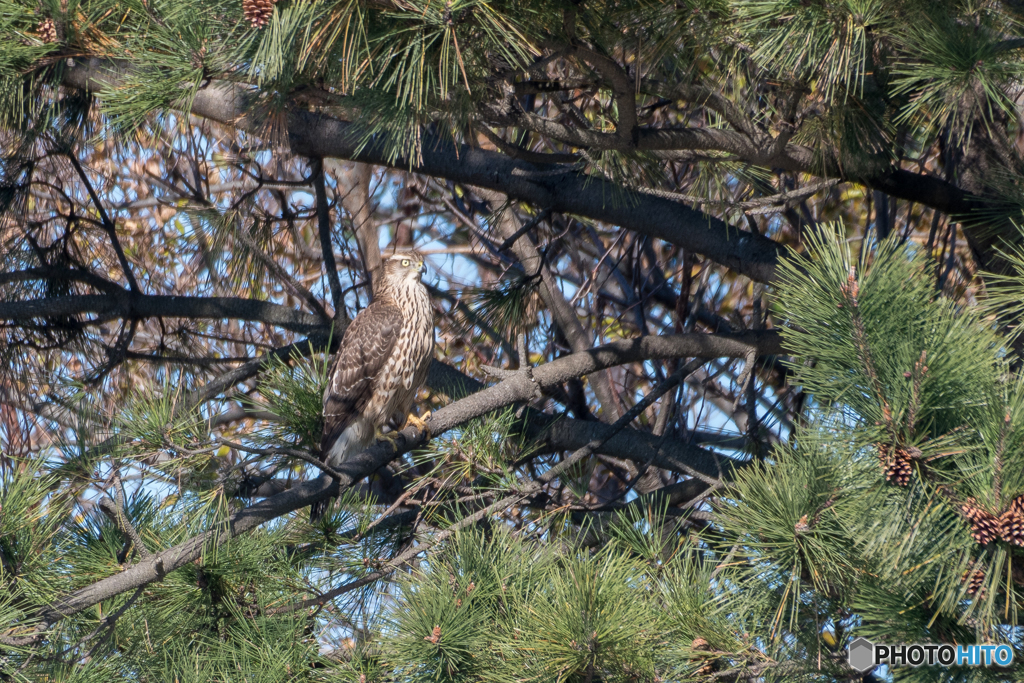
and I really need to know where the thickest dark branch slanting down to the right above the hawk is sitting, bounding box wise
[58,59,783,282]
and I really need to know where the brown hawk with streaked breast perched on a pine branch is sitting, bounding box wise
[309,252,434,521]
